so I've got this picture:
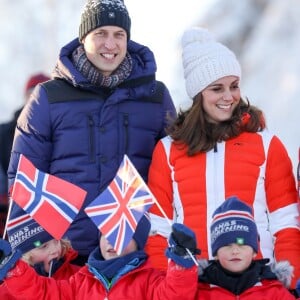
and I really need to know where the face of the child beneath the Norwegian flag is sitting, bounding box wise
[28,239,62,273]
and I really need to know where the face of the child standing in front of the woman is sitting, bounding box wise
[216,244,256,272]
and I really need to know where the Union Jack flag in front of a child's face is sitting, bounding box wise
[84,155,155,254]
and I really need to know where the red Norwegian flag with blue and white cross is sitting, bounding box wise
[11,155,86,239]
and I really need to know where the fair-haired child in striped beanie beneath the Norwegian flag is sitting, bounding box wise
[0,202,80,300]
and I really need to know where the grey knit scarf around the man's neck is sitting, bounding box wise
[72,45,132,88]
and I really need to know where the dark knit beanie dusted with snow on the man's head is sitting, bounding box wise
[79,0,131,41]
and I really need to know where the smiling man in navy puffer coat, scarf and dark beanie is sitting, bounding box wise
[8,0,176,264]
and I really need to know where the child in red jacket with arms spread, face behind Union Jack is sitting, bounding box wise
[0,216,199,300]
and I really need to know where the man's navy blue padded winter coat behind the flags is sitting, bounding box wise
[8,39,176,256]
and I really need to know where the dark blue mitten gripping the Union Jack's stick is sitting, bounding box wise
[166,223,200,268]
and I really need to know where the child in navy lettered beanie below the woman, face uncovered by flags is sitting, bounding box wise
[196,197,295,300]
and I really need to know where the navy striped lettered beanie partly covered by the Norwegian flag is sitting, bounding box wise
[7,202,54,254]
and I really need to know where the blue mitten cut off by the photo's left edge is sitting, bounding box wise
[0,239,22,280]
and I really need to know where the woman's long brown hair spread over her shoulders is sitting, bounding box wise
[167,93,266,156]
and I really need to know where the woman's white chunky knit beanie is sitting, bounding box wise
[181,27,241,99]
